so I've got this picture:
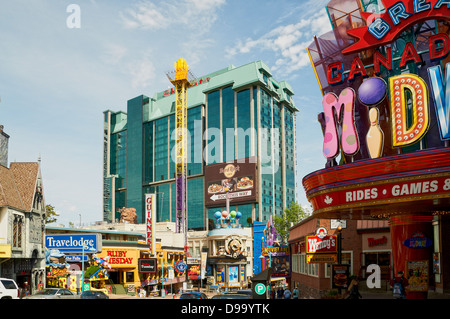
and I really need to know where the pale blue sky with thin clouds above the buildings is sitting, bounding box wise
[0,0,331,225]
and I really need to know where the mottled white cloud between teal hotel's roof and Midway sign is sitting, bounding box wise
[226,9,331,75]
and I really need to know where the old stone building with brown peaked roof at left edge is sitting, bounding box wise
[0,126,45,292]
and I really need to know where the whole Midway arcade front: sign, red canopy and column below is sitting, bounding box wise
[303,0,450,299]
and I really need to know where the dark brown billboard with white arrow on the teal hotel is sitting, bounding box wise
[205,157,257,207]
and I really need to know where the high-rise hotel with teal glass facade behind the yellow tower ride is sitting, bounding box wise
[103,61,298,230]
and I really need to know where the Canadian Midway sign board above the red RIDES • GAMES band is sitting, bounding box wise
[308,0,450,167]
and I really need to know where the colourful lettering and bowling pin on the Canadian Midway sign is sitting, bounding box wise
[322,0,450,160]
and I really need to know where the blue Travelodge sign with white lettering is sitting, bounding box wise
[45,234,102,254]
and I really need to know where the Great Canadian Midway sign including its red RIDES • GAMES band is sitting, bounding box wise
[303,0,450,219]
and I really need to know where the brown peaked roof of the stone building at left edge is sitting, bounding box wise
[0,162,39,211]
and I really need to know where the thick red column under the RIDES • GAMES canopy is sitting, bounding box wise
[389,215,433,299]
